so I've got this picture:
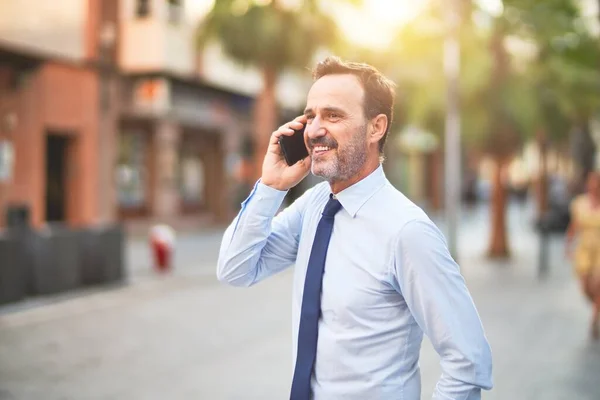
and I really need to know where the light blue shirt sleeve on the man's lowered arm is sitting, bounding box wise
[394,220,493,400]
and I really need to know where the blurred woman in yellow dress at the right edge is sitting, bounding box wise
[566,171,600,339]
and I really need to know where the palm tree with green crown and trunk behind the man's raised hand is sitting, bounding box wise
[197,0,338,173]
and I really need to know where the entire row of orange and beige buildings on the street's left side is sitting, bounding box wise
[0,0,307,231]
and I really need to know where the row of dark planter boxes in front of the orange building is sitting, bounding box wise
[0,224,125,304]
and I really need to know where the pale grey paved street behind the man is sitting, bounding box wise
[0,202,600,400]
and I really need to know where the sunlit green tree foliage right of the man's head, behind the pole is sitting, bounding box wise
[370,0,600,152]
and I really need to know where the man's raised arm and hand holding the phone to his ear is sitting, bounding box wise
[217,116,310,286]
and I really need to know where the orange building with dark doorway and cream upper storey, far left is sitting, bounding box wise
[0,0,114,227]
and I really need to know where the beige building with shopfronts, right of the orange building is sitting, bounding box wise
[115,0,253,228]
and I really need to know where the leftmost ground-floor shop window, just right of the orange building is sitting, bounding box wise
[116,132,148,208]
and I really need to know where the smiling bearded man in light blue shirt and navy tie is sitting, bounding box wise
[217,57,492,400]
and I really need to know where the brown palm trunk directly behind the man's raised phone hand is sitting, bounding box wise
[254,67,277,178]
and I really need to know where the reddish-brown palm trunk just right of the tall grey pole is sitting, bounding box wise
[488,157,510,258]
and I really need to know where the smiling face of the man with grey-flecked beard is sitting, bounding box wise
[304,74,368,182]
